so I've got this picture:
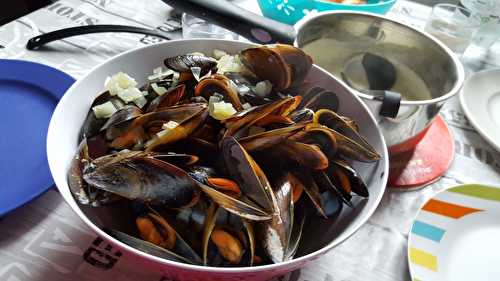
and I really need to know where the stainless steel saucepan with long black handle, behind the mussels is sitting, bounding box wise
[163,0,465,147]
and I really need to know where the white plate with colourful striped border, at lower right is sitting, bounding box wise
[408,184,500,281]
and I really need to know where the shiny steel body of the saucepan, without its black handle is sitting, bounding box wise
[297,13,464,146]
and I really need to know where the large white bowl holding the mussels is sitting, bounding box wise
[47,39,388,281]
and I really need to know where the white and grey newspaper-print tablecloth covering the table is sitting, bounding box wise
[0,0,500,281]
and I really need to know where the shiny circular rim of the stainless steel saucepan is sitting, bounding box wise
[294,10,465,105]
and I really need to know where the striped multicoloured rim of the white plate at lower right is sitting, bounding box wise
[408,184,500,281]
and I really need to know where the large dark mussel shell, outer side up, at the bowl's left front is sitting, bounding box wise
[83,156,199,208]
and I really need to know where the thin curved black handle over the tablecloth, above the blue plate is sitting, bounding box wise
[26,24,170,50]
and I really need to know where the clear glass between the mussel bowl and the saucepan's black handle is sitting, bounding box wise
[182,13,238,40]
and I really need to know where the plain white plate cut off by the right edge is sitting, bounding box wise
[460,69,500,151]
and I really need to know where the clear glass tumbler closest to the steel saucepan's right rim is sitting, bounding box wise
[425,4,481,54]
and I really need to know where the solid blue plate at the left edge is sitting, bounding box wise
[0,59,75,217]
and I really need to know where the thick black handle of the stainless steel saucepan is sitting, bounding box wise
[162,0,296,44]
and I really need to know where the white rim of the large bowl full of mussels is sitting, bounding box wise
[46,38,389,274]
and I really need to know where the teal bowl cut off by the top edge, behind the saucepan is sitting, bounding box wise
[257,0,396,24]
